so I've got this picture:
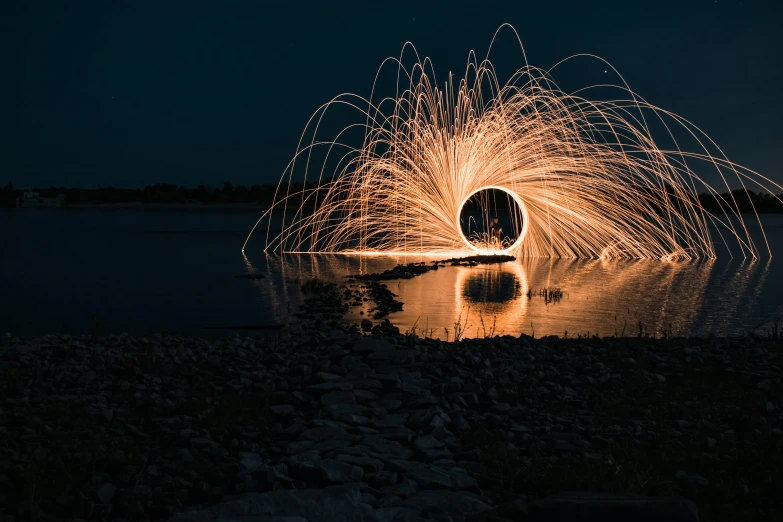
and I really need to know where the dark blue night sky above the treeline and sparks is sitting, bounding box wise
[0,0,783,187]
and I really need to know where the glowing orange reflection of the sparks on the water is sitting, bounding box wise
[258,255,779,339]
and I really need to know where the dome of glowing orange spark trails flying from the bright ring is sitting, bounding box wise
[243,25,781,260]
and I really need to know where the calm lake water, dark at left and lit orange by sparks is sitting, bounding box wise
[0,208,783,338]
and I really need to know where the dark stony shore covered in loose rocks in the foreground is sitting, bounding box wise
[0,324,783,522]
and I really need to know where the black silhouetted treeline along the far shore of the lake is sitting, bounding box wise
[0,182,783,213]
